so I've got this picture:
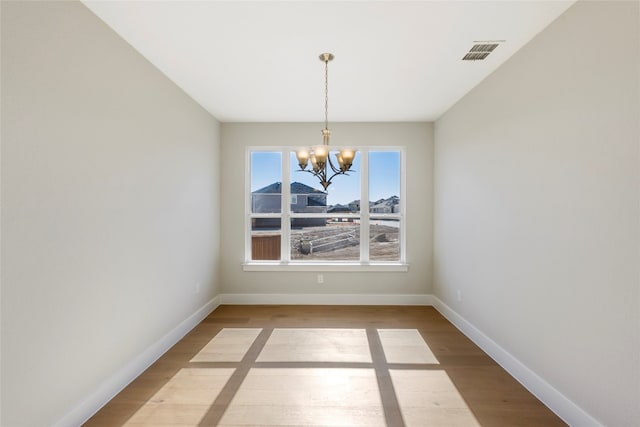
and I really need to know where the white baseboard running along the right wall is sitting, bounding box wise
[431,295,603,427]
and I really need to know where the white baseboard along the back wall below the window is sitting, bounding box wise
[220,294,432,305]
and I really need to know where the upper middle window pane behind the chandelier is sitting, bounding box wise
[290,151,360,212]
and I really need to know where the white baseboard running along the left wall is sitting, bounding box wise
[54,296,220,427]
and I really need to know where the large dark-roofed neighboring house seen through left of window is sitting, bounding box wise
[251,182,327,228]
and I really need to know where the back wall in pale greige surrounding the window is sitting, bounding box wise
[221,123,433,303]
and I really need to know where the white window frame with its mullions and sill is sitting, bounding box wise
[242,146,409,272]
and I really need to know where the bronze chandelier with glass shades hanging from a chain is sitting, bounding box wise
[296,53,356,191]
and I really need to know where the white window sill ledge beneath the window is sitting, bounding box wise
[242,261,409,272]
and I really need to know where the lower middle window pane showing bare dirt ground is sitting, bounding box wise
[291,218,360,261]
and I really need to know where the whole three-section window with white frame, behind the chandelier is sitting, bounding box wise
[245,147,405,267]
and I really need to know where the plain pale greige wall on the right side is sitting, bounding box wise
[434,1,640,426]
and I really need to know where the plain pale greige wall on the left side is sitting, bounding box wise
[2,1,220,426]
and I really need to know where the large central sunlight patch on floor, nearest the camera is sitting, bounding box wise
[219,368,386,426]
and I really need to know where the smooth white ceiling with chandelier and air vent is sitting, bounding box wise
[84,0,575,122]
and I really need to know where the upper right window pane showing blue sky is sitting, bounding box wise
[369,151,400,213]
